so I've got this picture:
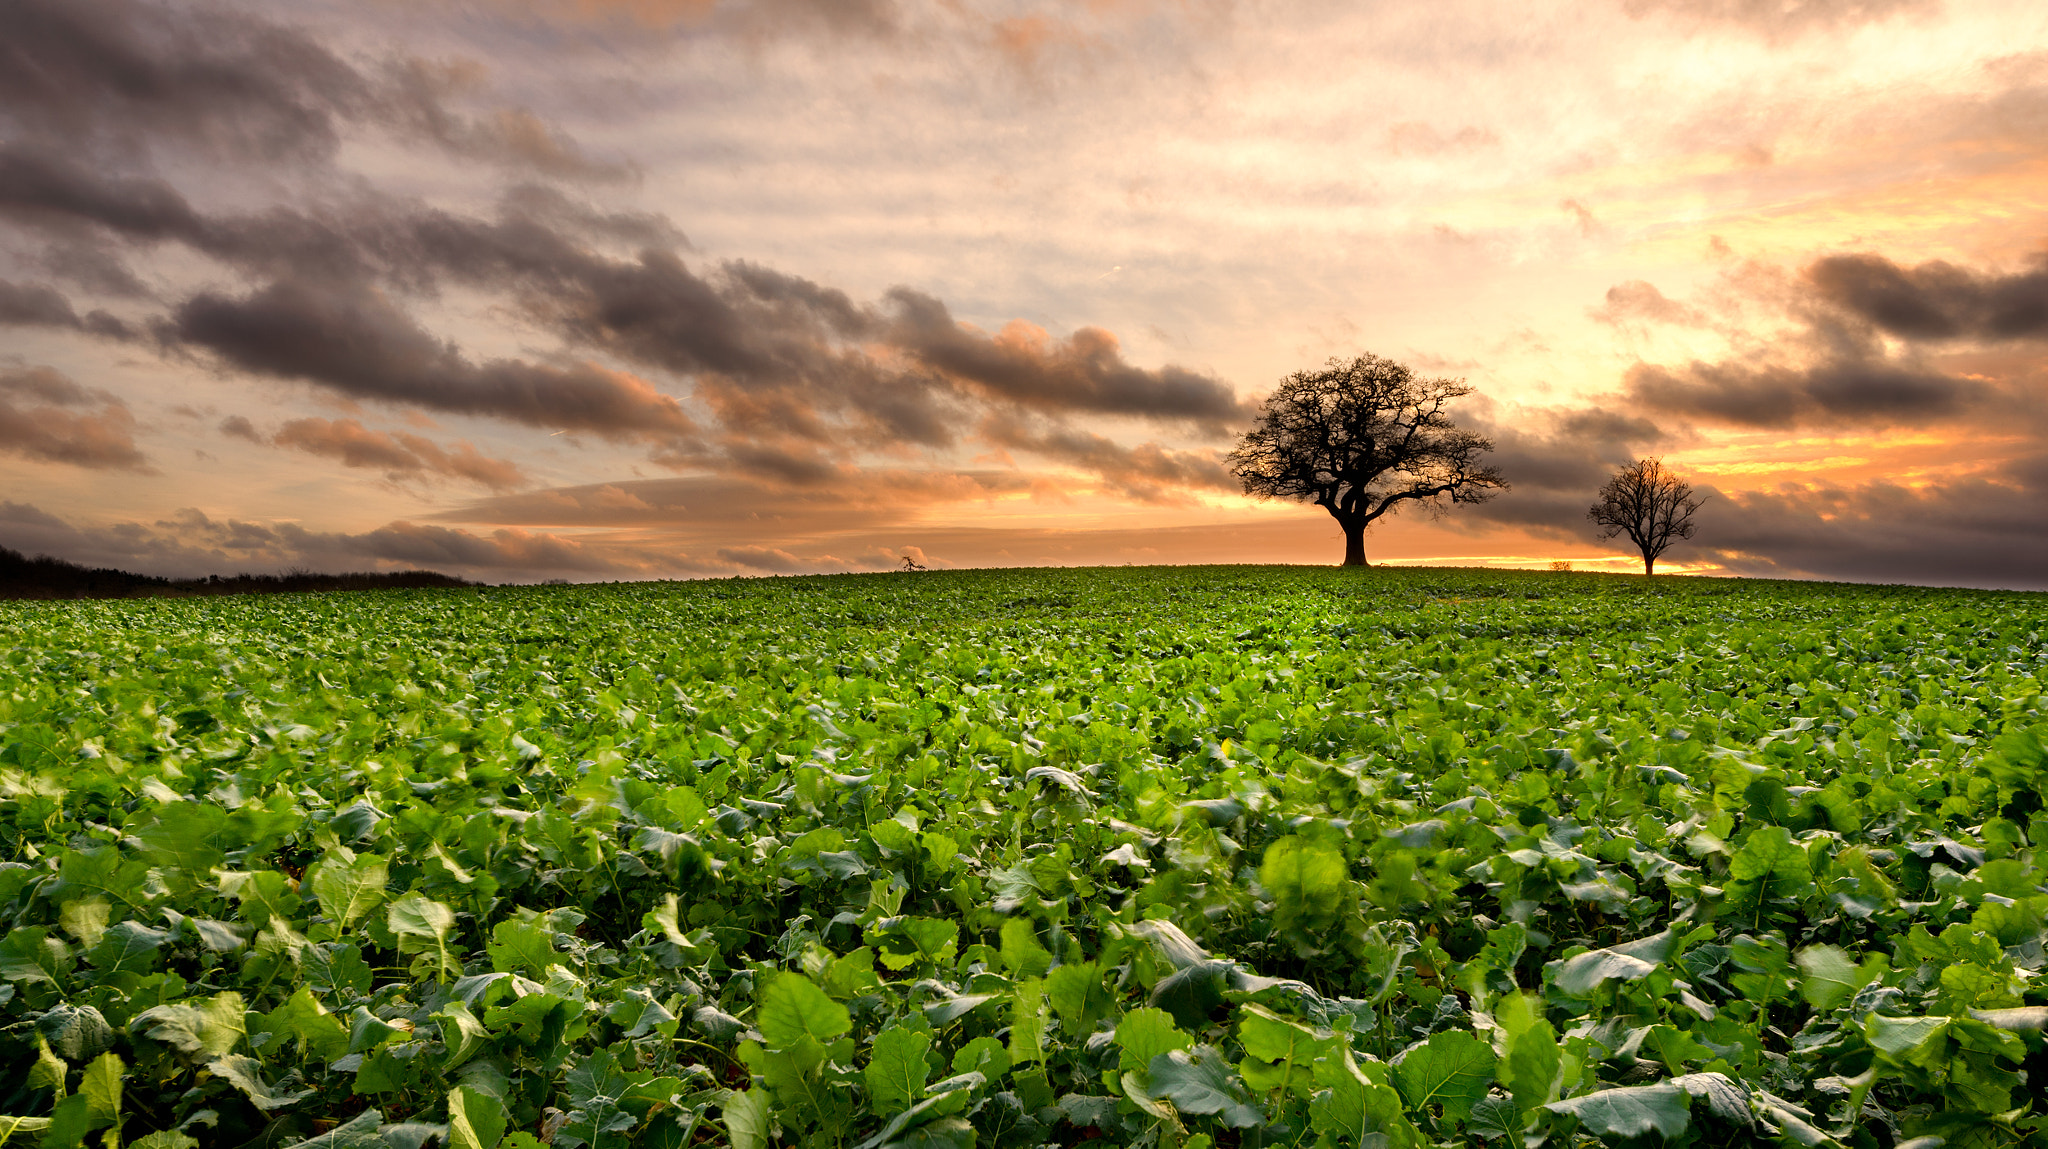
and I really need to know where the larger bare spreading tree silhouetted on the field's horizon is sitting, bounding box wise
[1231,354,1507,567]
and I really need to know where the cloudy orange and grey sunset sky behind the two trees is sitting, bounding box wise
[0,0,2048,588]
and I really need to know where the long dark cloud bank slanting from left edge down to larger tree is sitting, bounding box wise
[0,124,1249,481]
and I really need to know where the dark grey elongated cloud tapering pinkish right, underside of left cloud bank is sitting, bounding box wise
[164,283,696,442]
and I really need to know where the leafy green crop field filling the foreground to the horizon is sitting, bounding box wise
[0,567,2048,1149]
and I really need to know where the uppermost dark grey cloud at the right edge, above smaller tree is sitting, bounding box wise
[1806,254,2048,340]
